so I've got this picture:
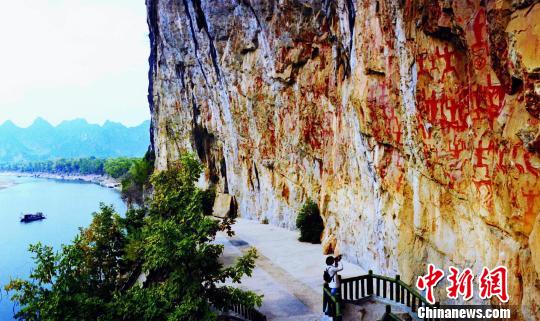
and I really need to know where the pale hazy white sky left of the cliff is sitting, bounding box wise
[0,0,150,126]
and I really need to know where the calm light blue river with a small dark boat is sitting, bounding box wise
[0,176,126,321]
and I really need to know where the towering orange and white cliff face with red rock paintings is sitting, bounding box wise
[147,0,540,320]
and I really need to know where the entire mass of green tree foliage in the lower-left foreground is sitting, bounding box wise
[6,155,261,321]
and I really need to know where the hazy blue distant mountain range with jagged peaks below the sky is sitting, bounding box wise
[0,118,150,163]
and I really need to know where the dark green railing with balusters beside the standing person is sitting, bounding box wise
[323,270,438,321]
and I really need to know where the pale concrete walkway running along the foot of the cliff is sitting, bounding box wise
[216,219,366,321]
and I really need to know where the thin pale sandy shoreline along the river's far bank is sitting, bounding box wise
[0,172,121,191]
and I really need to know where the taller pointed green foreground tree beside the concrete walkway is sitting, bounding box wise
[113,154,261,321]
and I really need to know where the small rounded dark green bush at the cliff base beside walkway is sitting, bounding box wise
[296,199,324,244]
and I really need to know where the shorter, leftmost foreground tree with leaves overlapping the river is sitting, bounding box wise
[6,205,125,321]
